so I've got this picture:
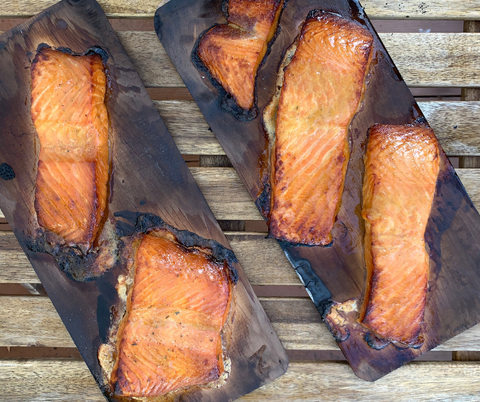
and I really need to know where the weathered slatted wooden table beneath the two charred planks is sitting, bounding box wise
[0,0,480,401]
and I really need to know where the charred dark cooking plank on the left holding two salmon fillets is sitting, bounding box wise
[0,0,288,402]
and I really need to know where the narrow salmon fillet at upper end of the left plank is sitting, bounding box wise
[31,47,109,250]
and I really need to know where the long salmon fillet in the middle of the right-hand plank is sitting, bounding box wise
[269,12,373,245]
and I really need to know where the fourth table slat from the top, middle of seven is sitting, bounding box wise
[2,167,480,220]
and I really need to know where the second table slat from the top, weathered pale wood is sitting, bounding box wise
[117,31,480,87]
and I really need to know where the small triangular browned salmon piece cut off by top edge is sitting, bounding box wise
[198,0,283,110]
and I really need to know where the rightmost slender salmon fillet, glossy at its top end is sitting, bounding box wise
[360,125,440,346]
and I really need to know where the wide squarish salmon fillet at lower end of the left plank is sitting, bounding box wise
[116,234,232,397]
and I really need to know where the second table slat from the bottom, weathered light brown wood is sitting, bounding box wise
[0,296,480,351]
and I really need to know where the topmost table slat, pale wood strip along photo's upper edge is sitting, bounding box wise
[0,0,480,20]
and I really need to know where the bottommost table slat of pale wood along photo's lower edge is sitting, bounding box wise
[0,359,480,402]
